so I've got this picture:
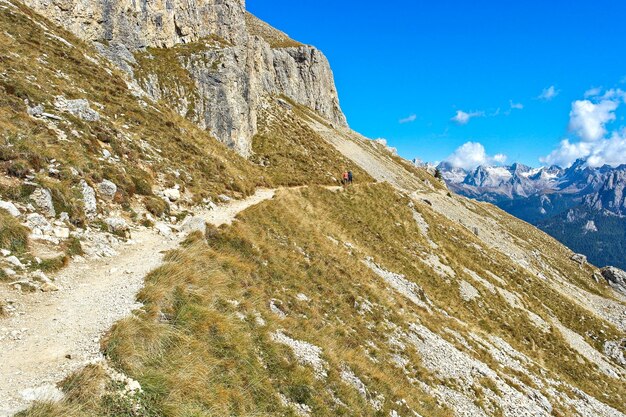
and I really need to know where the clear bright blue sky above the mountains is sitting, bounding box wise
[247,0,626,166]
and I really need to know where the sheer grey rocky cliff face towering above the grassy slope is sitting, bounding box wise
[24,0,347,156]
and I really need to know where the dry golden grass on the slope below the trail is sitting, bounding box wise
[20,184,626,417]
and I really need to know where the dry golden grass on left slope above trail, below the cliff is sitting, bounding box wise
[0,3,269,213]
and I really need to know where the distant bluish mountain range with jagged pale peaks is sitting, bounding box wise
[437,160,626,268]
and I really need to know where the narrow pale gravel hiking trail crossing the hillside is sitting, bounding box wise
[0,189,276,417]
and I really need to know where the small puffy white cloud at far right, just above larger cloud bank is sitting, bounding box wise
[569,100,618,142]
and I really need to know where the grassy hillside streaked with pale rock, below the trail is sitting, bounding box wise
[25,180,626,416]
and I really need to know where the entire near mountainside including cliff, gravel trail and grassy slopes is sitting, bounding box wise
[0,0,626,417]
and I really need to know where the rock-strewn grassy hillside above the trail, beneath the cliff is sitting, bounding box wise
[0,1,360,289]
